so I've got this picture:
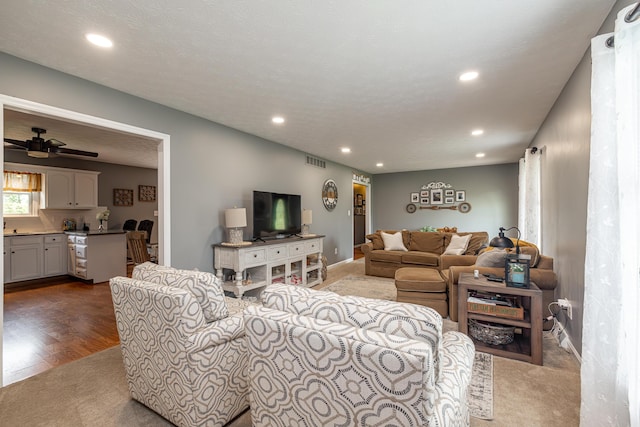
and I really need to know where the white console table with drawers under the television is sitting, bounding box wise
[213,235,324,298]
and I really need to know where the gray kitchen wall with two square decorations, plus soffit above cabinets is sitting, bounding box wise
[4,150,158,243]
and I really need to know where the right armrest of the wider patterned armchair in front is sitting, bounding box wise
[434,331,475,426]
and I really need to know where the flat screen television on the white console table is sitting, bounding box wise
[253,191,302,240]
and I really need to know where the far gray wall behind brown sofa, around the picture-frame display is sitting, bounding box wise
[371,163,518,236]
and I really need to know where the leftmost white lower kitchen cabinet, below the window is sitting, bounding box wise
[9,236,43,282]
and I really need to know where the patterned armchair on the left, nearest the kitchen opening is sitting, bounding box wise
[110,263,249,426]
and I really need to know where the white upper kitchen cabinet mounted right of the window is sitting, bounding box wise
[45,169,98,209]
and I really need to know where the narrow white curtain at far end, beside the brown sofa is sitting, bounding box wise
[518,148,542,248]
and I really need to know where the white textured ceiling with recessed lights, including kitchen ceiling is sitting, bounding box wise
[0,0,615,173]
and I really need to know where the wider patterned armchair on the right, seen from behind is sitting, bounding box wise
[244,285,475,427]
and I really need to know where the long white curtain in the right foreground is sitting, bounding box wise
[580,5,640,427]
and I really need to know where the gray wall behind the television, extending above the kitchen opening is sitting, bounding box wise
[0,53,360,271]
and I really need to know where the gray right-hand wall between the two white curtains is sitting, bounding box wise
[531,0,635,353]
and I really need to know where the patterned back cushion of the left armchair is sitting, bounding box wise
[132,262,229,322]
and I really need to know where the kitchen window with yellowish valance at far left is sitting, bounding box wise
[2,172,42,216]
